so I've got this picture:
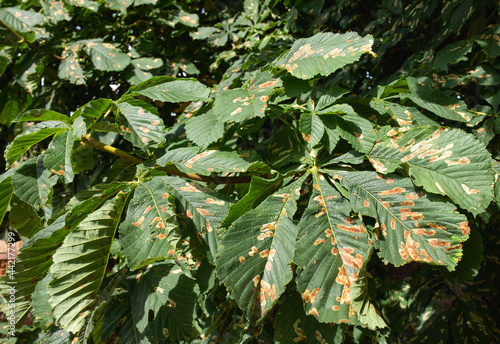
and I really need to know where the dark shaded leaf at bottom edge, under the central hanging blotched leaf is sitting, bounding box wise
[274,293,346,344]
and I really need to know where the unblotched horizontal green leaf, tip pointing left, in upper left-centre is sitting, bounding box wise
[126,76,210,103]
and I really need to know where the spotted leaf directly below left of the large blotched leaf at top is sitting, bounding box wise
[214,72,282,123]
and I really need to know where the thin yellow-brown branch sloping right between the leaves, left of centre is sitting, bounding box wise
[82,134,252,184]
